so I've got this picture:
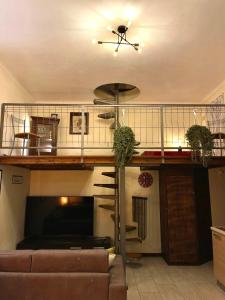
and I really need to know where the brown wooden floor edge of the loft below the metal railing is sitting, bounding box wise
[0,156,225,170]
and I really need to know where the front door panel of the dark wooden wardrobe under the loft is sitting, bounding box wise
[166,175,198,264]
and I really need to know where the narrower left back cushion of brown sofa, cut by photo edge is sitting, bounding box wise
[0,250,33,272]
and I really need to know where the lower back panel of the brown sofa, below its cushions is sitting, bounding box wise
[0,272,110,300]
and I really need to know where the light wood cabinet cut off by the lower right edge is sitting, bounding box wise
[212,227,225,286]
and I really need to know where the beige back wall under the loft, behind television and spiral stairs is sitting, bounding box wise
[30,167,161,253]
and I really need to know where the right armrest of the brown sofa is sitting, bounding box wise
[109,255,127,300]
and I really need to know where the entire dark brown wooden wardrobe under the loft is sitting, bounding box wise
[160,166,212,264]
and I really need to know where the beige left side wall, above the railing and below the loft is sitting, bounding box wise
[0,64,32,249]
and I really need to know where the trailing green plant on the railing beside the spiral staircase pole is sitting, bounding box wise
[113,126,136,167]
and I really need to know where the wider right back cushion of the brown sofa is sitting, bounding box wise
[31,249,108,273]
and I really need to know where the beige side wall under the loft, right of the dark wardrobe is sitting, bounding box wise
[209,167,225,226]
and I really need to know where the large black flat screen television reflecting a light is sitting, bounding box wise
[24,196,94,237]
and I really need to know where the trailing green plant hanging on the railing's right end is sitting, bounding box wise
[185,125,213,167]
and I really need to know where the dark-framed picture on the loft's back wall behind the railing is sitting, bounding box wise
[70,112,89,134]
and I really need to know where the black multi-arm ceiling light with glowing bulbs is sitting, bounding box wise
[98,25,140,56]
